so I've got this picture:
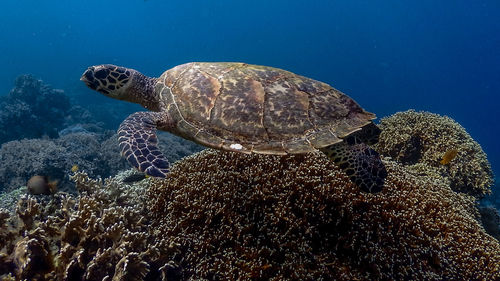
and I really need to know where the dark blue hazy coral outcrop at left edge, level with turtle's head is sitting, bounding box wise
[0,75,71,143]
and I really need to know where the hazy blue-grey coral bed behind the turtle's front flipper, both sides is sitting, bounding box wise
[0,128,201,192]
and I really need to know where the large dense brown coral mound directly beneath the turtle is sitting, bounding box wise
[148,150,500,280]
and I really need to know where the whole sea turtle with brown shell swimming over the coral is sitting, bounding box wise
[81,62,387,192]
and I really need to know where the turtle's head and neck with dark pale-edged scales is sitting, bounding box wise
[80,64,158,110]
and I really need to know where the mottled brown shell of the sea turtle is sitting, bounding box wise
[155,63,375,154]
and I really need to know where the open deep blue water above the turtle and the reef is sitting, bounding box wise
[0,0,500,187]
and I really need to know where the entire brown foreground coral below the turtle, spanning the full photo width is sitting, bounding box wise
[0,150,500,280]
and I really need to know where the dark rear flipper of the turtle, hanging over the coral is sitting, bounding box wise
[320,136,387,193]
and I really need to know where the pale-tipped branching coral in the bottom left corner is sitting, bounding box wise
[0,171,176,280]
